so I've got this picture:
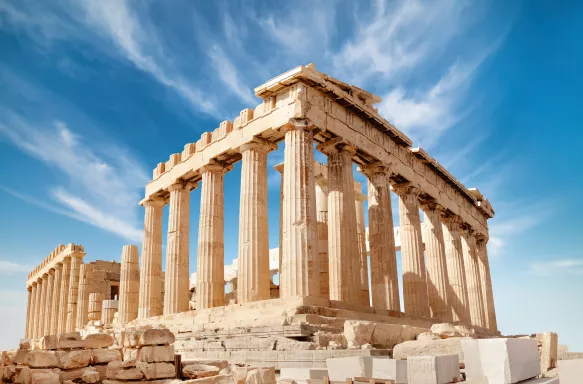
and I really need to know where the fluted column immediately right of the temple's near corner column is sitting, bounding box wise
[318,140,362,304]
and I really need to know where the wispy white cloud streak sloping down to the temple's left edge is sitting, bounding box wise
[0,111,149,241]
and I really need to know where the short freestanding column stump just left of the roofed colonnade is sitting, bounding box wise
[118,245,140,324]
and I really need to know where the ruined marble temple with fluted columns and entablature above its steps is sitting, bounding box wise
[22,65,497,337]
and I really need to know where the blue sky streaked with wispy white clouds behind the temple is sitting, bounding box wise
[0,0,583,350]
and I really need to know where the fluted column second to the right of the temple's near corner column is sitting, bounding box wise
[362,164,401,312]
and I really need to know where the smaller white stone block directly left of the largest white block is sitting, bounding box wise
[407,355,460,384]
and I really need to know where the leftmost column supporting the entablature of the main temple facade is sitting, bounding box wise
[138,199,165,319]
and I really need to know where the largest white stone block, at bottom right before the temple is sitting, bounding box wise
[461,338,540,384]
